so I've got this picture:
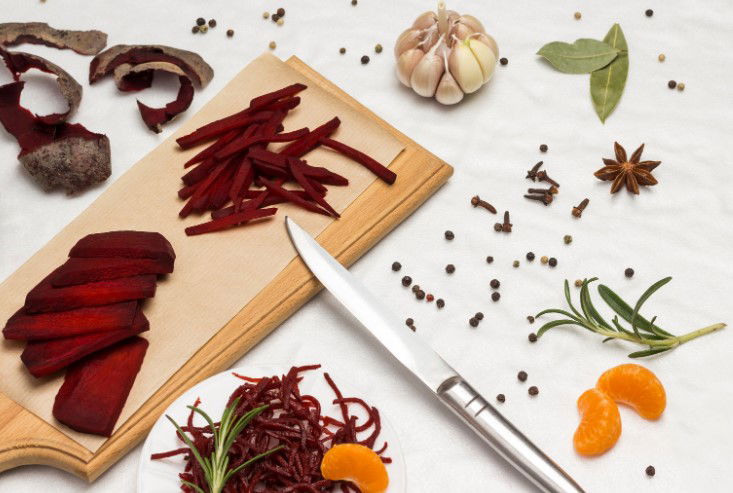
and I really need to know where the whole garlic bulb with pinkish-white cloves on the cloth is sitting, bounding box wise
[394,0,499,104]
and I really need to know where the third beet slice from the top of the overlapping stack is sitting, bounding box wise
[24,269,156,313]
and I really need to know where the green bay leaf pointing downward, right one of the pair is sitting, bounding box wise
[590,24,629,123]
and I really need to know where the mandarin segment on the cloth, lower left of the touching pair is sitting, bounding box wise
[573,389,621,456]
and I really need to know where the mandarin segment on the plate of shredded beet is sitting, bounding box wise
[321,443,389,493]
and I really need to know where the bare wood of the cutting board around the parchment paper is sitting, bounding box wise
[0,57,453,481]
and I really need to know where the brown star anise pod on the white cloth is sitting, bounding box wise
[594,142,661,194]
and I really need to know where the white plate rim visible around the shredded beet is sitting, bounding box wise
[137,366,406,493]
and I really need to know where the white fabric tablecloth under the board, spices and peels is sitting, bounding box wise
[0,0,733,493]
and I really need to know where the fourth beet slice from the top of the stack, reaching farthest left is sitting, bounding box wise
[3,301,138,340]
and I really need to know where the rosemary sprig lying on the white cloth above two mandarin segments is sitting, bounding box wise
[536,277,725,358]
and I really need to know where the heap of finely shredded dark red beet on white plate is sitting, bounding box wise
[151,365,391,493]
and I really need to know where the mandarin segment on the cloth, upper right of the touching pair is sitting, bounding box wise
[596,363,667,419]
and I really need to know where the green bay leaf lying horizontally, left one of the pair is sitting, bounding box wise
[537,39,619,74]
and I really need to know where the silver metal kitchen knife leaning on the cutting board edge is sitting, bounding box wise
[285,217,583,493]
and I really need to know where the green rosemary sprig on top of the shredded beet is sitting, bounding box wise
[165,398,283,493]
